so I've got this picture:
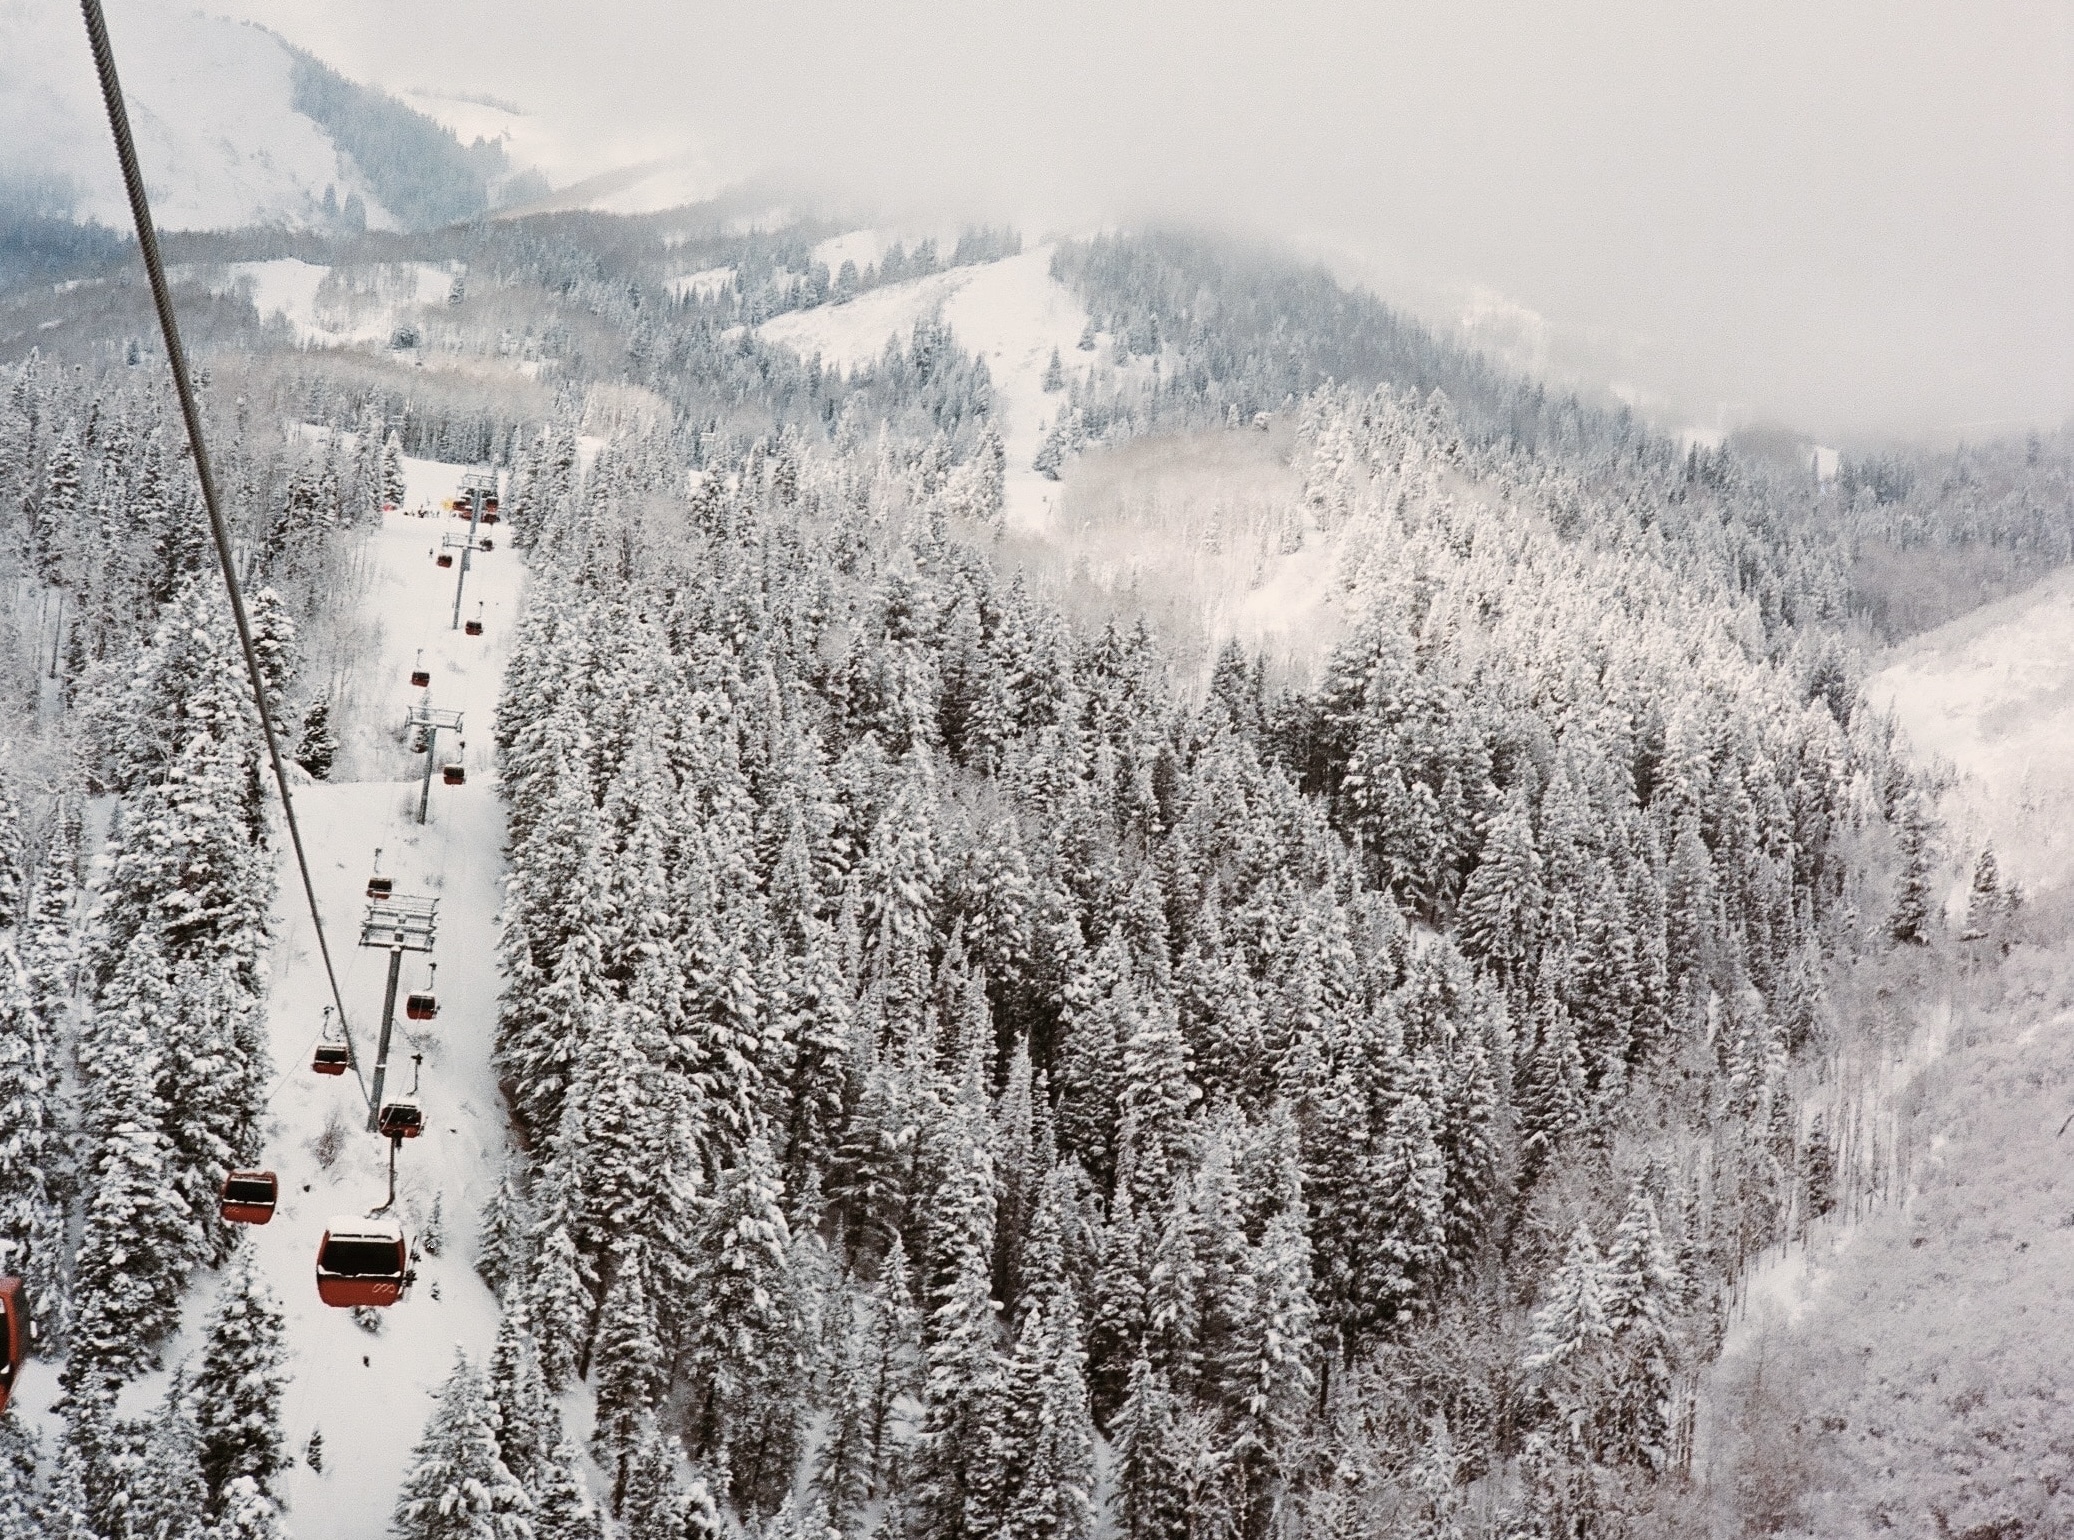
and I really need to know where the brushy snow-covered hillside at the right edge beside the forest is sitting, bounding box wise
[1705,570,2074,1536]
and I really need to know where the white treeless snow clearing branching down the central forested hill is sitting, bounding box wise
[757,232,1087,531]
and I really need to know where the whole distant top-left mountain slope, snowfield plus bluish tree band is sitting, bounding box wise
[0,0,526,230]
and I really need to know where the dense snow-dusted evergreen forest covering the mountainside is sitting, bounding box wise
[0,216,2070,1540]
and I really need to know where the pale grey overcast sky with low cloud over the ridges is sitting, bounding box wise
[198,0,2074,435]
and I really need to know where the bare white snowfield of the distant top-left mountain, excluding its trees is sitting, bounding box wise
[0,0,394,230]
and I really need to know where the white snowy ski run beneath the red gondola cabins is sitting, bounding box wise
[17,460,535,1540]
